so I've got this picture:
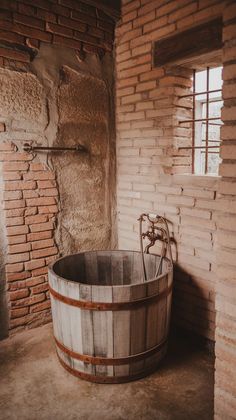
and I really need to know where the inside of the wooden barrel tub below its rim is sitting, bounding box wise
[53,251,168,286]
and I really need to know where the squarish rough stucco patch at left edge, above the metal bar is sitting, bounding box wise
[0,70,46,125]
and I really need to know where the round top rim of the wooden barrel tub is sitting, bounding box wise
[48,249,173,288]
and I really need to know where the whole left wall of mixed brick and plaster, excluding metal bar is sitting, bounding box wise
[0,0,116,335]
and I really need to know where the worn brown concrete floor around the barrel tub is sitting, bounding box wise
[0,325,213,420]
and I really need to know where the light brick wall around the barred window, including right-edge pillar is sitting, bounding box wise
[116,0,236,420]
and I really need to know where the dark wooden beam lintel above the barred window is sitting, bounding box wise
[154,18,222,67]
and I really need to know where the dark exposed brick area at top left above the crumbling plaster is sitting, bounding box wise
[0,0,114,68]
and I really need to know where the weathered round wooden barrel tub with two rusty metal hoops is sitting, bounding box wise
[49,251,173,383]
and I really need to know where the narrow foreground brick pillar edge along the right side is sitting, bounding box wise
[215,1,236,420]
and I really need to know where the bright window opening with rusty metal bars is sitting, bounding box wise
[179,67,223,174]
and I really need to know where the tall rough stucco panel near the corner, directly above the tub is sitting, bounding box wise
[53,68,111,254]
